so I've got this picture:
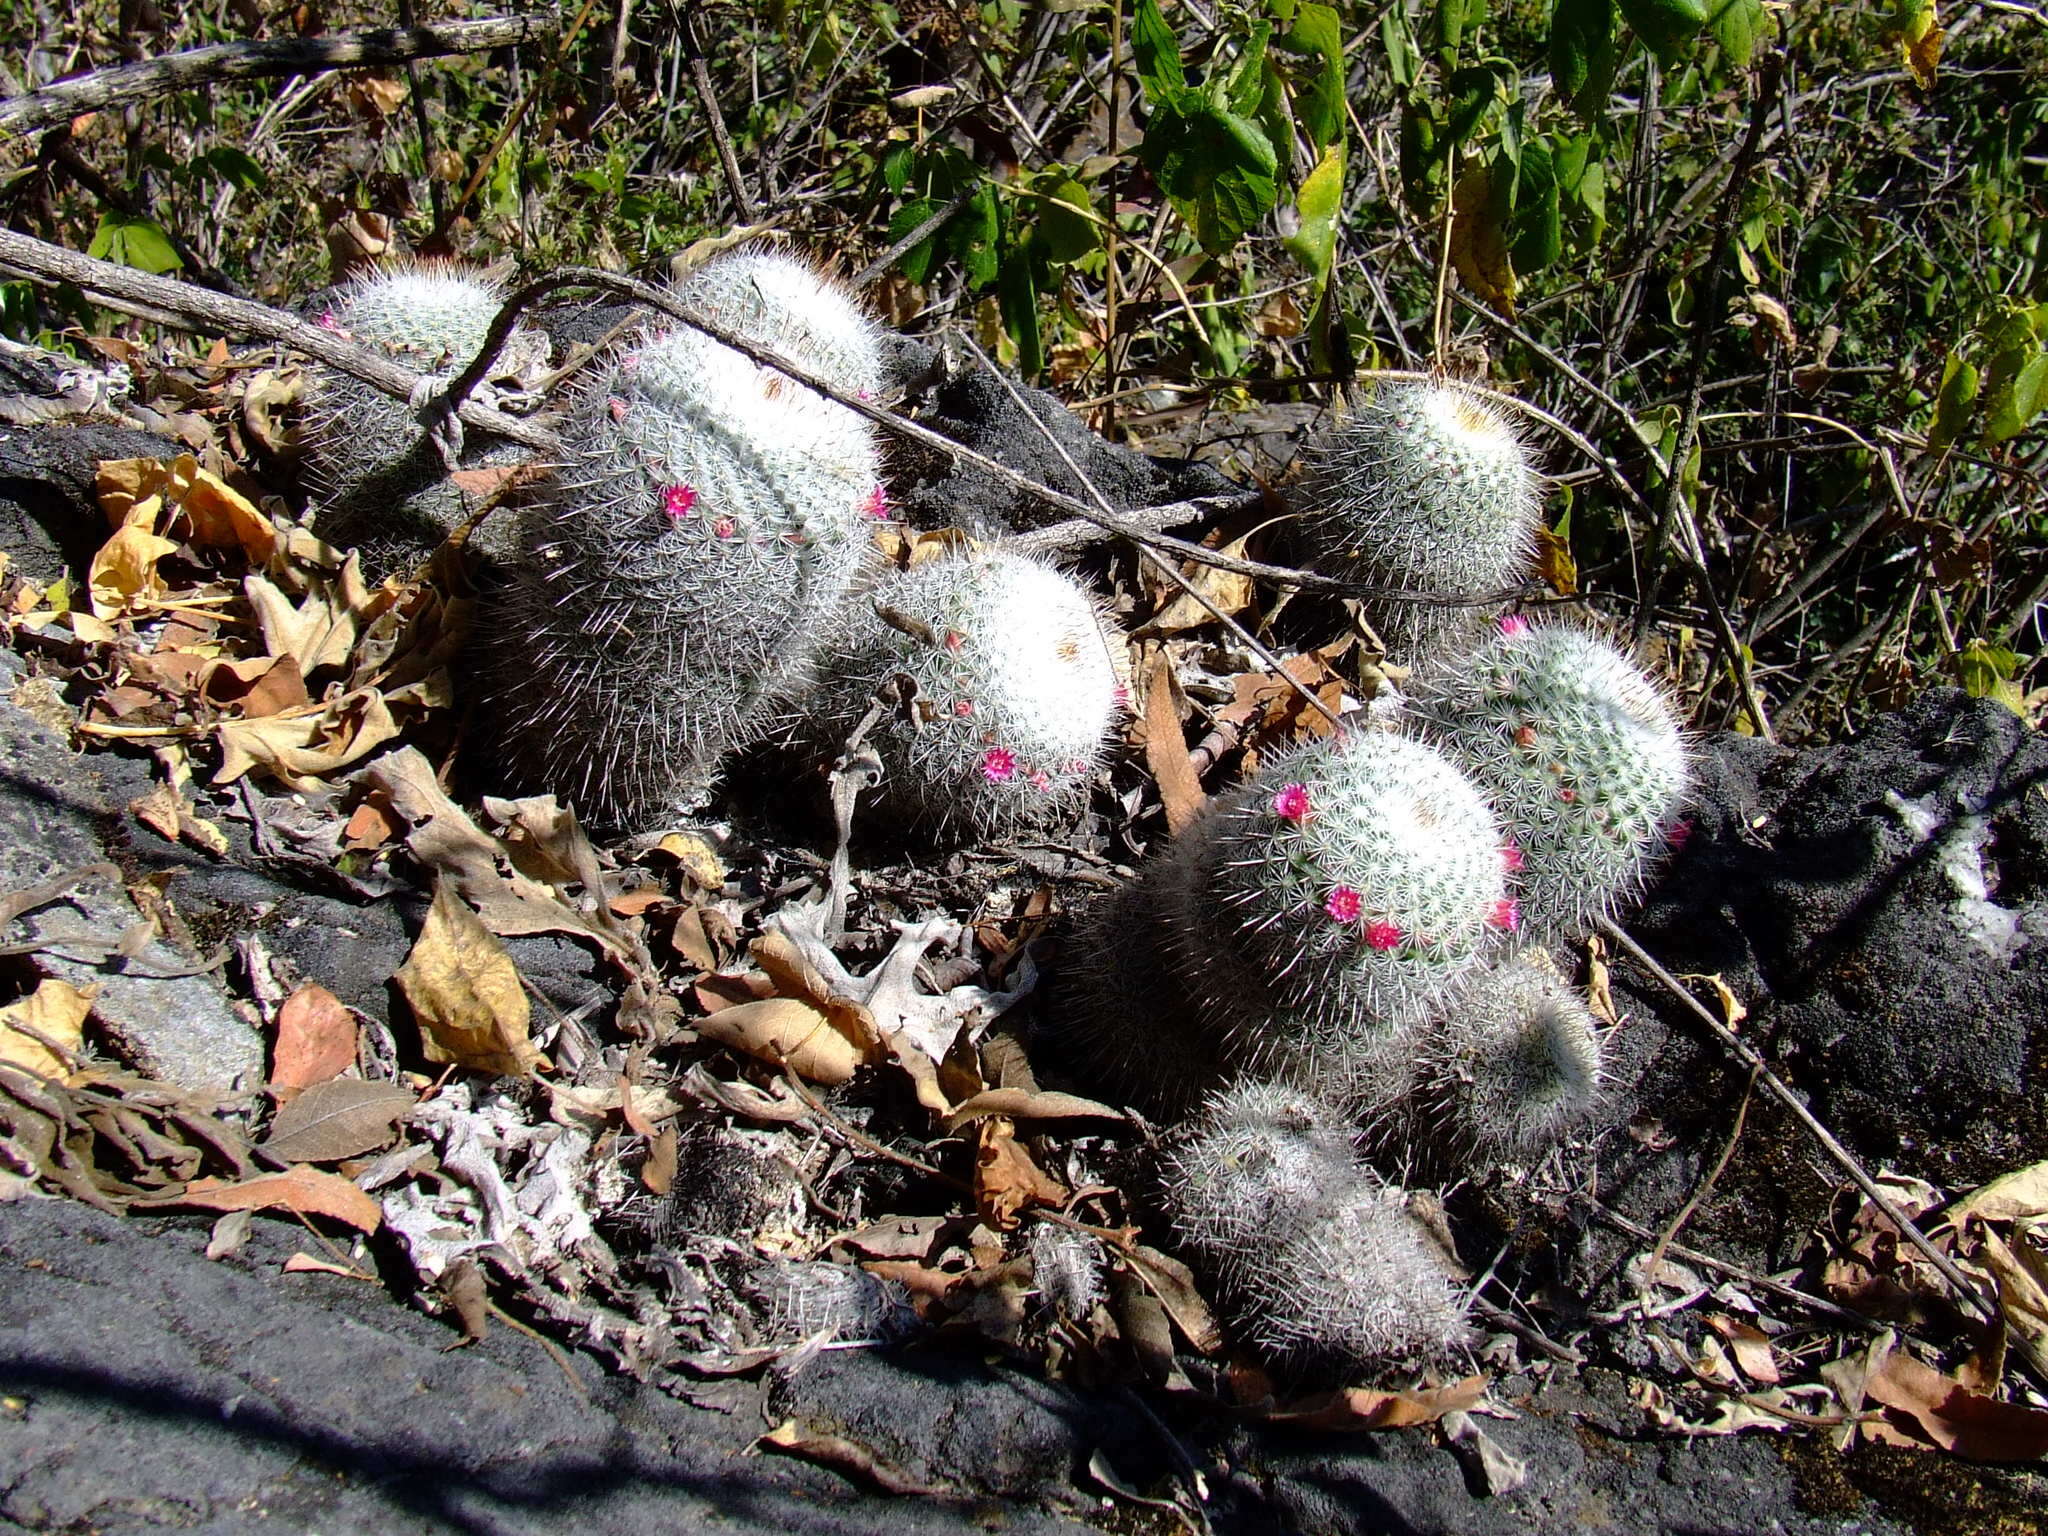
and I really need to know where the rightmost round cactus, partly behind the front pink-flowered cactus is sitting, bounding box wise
[1411,618,1690,938]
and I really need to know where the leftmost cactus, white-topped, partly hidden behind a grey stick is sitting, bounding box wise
[305,266,549,563]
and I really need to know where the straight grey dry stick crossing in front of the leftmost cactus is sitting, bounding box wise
[0,229,559,453]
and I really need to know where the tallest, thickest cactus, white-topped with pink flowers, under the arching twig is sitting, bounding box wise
[487,328,885,827]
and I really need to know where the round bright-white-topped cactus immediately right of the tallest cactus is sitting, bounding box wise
[809,549,1124,834]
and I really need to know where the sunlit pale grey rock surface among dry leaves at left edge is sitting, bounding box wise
[0,651,262,1094]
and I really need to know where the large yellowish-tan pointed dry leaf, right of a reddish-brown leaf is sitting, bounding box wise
[395,881,547,1077]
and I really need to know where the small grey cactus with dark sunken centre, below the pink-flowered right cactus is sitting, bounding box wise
[1409,948,1599,1169]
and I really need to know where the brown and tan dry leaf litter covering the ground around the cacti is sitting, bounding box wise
[0,373,2048,1531]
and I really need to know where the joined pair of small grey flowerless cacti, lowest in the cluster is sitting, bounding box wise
[1161,1085,1468,1372]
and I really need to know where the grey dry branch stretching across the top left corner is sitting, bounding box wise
[0,16,555,137]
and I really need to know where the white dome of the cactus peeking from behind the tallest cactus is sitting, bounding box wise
[674,248,887,399]
